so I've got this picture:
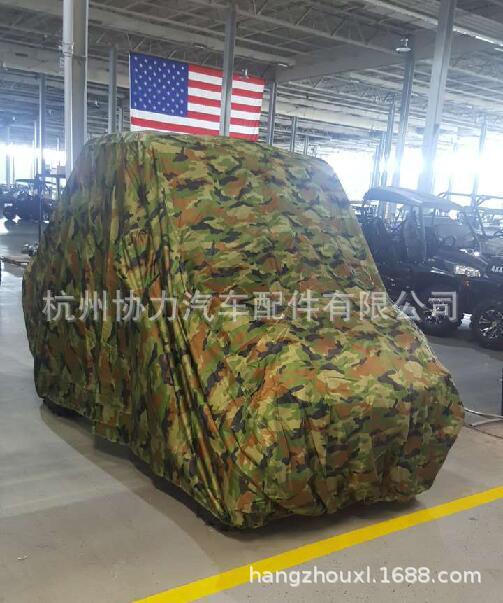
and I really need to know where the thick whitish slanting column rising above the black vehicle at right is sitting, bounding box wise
[419,0,457,193]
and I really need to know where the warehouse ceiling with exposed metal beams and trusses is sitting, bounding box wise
[0,0,503,149]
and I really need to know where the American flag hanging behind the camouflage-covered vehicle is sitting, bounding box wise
[129,53,264,140]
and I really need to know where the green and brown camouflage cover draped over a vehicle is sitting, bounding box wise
[23,133,463,527]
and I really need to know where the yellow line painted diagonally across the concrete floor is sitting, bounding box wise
[136,486,503,603]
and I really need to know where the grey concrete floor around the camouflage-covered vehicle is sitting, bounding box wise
[0,222,503,603]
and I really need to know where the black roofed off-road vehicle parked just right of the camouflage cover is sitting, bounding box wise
[357,187,503,349]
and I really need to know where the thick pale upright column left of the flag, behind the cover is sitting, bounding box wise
[62,0,89,177]
